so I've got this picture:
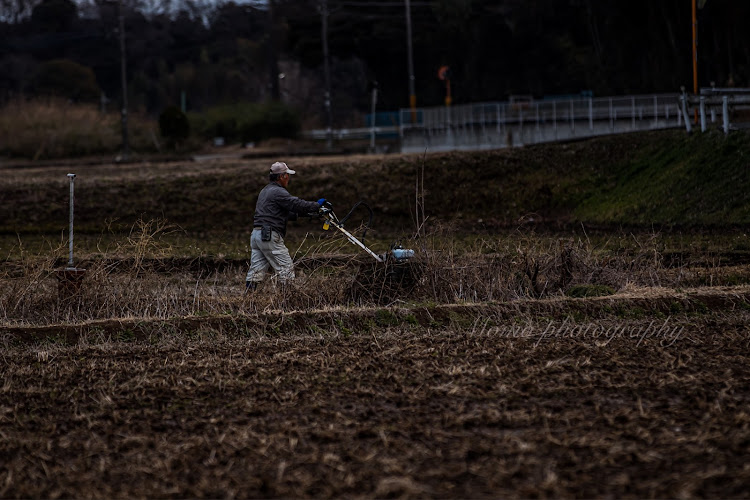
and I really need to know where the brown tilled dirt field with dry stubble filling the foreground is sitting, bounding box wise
[0,287,750,498]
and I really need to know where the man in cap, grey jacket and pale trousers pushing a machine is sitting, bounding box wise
[245,161,325,291]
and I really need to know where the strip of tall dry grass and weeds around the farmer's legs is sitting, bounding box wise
[0,220,732,326]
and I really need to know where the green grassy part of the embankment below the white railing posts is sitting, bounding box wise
[575,133,750,225]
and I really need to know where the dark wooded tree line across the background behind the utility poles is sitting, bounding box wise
[0,0,750,126]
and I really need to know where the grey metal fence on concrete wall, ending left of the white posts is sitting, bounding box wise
[399,94,684,152]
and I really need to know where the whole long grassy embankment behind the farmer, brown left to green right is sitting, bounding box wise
[0,131,750,234]
